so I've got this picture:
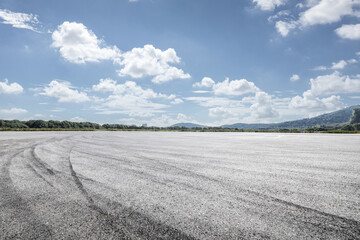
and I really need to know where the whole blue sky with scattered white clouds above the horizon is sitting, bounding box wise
[0,0,360,126]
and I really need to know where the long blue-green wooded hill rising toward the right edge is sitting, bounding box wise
[222,105,360,130]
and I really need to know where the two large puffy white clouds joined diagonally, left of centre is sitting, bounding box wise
[51,21,191,83]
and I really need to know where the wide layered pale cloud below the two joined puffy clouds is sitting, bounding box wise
[92,78,177,117]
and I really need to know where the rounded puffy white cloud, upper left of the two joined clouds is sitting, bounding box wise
[51,21,120,64]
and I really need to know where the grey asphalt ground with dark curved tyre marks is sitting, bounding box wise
[0,132,360,239]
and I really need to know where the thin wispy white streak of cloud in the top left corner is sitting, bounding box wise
[0,9,39,32]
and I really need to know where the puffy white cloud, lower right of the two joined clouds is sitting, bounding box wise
[117,45,191,83]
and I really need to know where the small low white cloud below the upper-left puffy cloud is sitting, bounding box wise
[40,80,90,103]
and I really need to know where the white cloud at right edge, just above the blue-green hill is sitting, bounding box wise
[310,71,360,96]
